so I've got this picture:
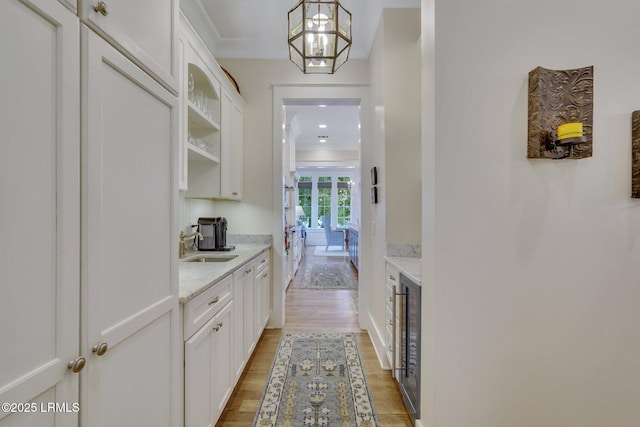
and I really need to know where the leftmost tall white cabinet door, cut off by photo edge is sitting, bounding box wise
[0,0,80,427]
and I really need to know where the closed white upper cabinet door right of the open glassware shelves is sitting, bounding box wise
[220,90,243,200]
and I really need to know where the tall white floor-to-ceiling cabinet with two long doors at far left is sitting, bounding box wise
[0,0,181,427]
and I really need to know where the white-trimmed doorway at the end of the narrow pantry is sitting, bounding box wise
[271,85,370,329]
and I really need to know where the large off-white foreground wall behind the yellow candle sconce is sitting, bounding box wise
[422,0,640,427]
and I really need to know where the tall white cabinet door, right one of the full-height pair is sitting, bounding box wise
[81,27,181,427]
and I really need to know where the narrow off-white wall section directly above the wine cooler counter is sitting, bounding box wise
[382,9,422,244]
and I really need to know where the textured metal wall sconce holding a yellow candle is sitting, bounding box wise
[527,67,593,159]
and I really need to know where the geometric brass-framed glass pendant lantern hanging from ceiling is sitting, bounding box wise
[289,0,351,74]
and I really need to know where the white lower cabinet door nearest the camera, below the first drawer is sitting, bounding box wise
[184,302,235,427]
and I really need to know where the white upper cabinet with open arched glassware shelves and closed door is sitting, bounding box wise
[178,15,246,200]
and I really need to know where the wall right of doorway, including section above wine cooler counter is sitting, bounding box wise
[362,9,421,364]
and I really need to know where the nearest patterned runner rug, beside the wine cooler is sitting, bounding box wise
[253,332,378,427]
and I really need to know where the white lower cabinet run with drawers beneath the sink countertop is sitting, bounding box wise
[183,250,270,427]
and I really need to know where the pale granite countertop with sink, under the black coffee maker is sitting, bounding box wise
[178,243,271,304]
